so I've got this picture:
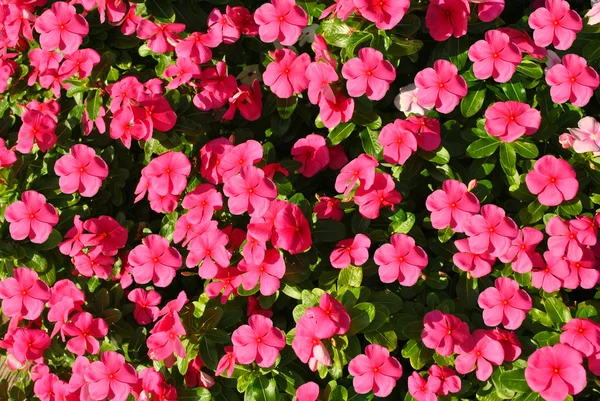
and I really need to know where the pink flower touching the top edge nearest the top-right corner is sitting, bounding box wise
[529,0,583,50]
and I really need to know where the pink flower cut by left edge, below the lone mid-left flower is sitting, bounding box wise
[0,267,50,320]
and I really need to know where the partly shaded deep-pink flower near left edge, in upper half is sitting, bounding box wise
[16,110,57,153]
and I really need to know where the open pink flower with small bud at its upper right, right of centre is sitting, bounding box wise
[425,180,479,233]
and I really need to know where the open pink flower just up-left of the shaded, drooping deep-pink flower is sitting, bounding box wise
[223,166,277,217]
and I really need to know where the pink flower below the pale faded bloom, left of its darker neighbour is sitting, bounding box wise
[378,119,417,165]
